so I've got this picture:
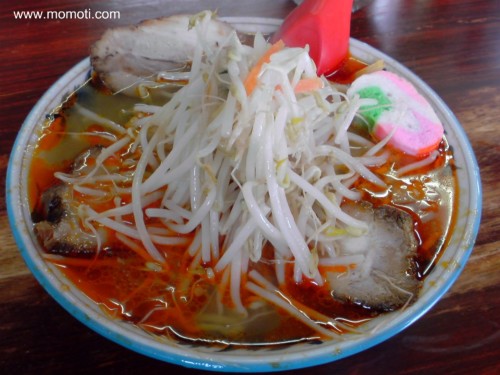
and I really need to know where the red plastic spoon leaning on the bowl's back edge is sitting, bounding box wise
[272,0,353,75]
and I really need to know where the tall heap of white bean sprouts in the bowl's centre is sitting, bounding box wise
[57,13,387,320]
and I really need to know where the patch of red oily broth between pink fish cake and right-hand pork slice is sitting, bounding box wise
[355,138,458,279]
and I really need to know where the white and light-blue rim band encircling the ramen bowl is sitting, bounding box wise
[6,17,482,372]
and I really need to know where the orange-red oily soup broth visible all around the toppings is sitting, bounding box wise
[29,62,457,345]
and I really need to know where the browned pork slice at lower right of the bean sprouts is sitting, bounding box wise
[328,203,421,311]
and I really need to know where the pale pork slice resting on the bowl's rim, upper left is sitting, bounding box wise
[91,15,234,96]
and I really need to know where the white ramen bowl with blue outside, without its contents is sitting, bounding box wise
[6,18,481,372]
